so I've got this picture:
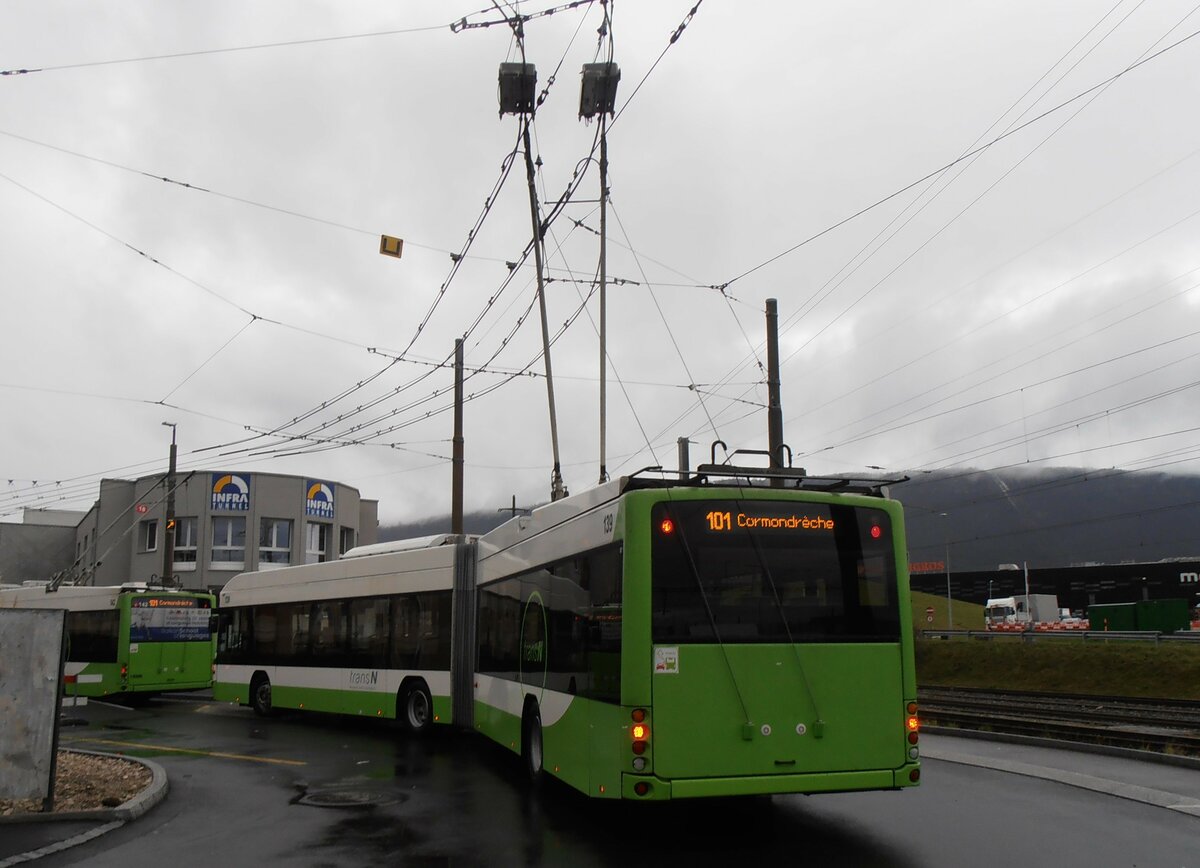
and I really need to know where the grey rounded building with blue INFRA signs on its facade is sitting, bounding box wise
[16,469,379,591]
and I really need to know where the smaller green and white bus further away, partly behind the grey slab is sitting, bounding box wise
[0,583,216,698]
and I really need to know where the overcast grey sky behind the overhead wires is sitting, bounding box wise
[0,0,1200,522]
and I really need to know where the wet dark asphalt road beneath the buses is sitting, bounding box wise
[38,700,1200,868]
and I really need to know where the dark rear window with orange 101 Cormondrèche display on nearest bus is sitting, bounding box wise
[650,501,900,643]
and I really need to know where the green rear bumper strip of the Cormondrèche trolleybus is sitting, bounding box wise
[620,762,920,802]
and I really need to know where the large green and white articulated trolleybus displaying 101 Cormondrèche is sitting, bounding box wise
[214,465,920,801]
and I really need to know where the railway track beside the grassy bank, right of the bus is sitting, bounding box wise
[917,688,1200,756]
